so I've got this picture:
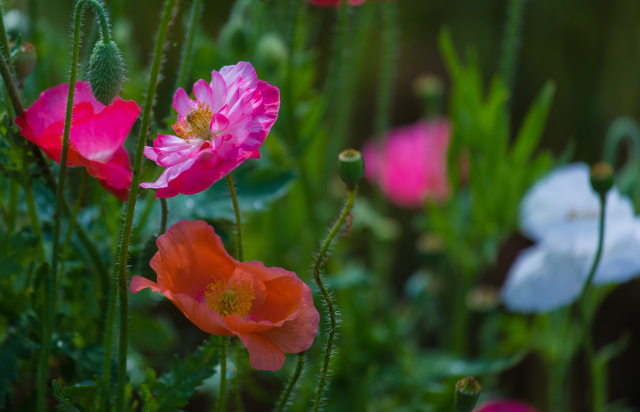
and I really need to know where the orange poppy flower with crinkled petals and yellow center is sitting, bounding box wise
[130,220,320,371]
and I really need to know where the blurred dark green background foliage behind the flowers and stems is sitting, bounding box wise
[0,0,640,412]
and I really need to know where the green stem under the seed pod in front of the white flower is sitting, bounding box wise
[578,195,606,412]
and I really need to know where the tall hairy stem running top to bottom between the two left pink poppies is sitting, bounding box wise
[114,0,176,412]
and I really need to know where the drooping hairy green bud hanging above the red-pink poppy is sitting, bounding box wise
[88,41,124,106]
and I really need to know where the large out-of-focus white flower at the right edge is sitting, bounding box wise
[501,163,640,313]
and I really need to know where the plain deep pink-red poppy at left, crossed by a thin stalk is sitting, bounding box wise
[16,82,140,202]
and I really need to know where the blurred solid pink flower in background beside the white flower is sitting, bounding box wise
[362,119,449,207]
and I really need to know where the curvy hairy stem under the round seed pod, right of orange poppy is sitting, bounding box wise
[313,188,357,412]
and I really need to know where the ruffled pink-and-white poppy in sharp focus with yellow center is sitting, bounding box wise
[140,62,280,197]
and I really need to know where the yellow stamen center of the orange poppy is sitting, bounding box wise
[204,280,256,317]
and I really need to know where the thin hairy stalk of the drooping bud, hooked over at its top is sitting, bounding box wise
[37,0,109,411]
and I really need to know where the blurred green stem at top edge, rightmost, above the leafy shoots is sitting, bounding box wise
[500,0,527,95]
